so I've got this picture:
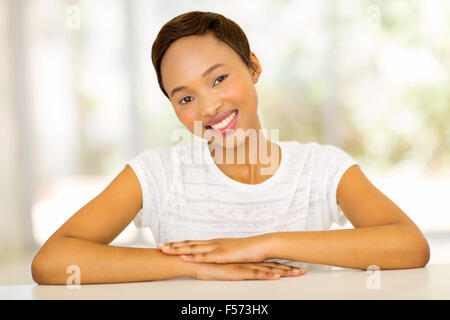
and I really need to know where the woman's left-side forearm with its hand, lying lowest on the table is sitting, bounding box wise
[32,237,306,285]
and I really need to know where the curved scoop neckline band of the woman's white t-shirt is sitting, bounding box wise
[202,140,289,191]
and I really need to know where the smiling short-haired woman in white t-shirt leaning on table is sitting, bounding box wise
[32,11,429,284]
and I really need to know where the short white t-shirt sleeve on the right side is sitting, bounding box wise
[317,145,359,227]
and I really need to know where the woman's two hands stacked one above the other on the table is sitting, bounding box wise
[157,236,306,278]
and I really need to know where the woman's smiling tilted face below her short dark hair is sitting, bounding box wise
[161,32,261,147]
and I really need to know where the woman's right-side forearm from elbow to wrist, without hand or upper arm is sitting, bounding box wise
[264,224,429,270]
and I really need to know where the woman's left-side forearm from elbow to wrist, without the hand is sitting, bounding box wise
[32,236,197,284]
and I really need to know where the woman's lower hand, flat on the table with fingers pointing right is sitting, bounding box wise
[195,262,306,280]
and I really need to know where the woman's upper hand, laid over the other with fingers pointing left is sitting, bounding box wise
[158,236,267,263]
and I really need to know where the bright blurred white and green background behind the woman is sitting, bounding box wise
[0,0,450,285]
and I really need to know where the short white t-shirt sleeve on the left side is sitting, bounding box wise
[126,149,168,232]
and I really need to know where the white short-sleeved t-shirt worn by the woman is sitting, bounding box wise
[126,140,359,270]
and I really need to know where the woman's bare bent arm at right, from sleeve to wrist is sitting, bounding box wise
[256,166,430,269]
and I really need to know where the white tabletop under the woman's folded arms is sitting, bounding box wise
[0,264,450,300]
